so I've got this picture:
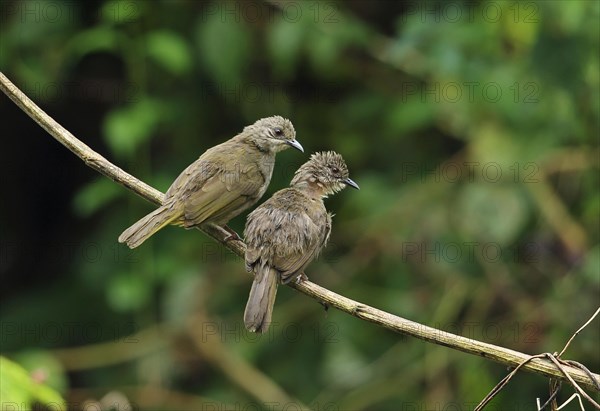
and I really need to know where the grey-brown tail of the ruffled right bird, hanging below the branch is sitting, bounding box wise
[244,265,279,333]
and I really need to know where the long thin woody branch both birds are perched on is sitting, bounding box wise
[0,72,600,391]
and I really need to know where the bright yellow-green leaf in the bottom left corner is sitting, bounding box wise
[0,357,66,410]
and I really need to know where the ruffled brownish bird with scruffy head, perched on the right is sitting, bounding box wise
[244,151,358,333]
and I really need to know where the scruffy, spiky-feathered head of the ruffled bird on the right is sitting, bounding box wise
[291,151,359,197]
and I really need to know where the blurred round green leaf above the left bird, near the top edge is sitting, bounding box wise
[146,30,192,74]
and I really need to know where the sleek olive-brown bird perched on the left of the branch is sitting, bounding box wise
[119,116,304,248]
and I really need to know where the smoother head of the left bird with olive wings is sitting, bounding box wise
[244,116,304,153]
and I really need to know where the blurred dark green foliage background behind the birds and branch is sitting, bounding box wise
[0,0,600,410]
